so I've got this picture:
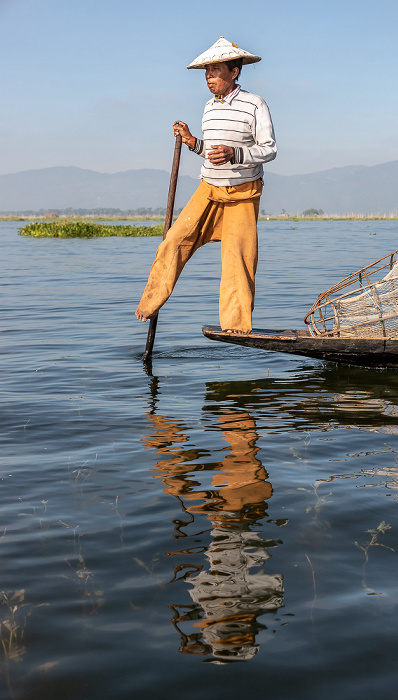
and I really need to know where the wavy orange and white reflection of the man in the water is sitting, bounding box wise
[147,412,284,663]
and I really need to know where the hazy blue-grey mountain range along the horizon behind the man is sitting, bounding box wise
[0,160,398,215]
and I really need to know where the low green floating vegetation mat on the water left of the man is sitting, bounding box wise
[19,221,163,238]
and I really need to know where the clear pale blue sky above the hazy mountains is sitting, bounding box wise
[0,0,398,176]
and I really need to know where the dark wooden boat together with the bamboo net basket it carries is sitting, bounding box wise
[202,250,398,367]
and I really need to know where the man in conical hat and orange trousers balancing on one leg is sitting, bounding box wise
[135,37,276,335]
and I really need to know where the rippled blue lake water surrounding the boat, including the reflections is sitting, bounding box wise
[0,221,398,700]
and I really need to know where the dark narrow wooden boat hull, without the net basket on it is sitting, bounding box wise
[202,326,398,367]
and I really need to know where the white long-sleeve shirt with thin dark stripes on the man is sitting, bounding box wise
[192,90,276,186]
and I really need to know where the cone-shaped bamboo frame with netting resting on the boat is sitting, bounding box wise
[304,250,398,338]
